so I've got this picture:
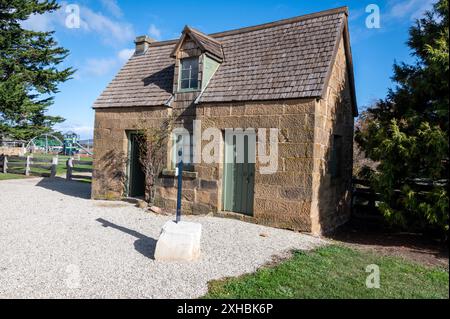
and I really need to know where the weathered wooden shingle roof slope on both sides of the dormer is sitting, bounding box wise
[94,8,352,108]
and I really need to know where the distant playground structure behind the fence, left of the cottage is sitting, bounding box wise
[26,132,92,156]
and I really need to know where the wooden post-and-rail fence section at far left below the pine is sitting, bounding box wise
[0,155,58,178]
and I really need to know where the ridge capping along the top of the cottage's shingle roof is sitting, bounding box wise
[150,6,348,47]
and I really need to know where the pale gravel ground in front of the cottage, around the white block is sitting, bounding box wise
[0,179,324,298]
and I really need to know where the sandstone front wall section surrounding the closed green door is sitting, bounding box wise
[196,100,315,231]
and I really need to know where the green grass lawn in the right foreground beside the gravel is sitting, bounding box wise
[204,246,449,299]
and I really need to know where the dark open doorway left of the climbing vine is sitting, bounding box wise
[128,132,145,197]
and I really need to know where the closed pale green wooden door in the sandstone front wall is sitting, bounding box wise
[223,135,256,216]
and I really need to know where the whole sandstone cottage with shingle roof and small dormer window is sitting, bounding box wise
[92,7,358,234]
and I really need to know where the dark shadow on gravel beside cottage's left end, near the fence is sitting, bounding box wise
[36,177,91,199]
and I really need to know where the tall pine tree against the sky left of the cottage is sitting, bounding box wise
[0,0,74,140]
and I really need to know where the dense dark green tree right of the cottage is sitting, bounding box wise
[356,0,449,232]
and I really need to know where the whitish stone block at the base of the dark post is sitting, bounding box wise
[155,221,202,262]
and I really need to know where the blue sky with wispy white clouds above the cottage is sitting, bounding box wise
[24,0,434,138]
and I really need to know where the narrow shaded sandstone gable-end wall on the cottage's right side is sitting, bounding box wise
[311,40,354,234]
